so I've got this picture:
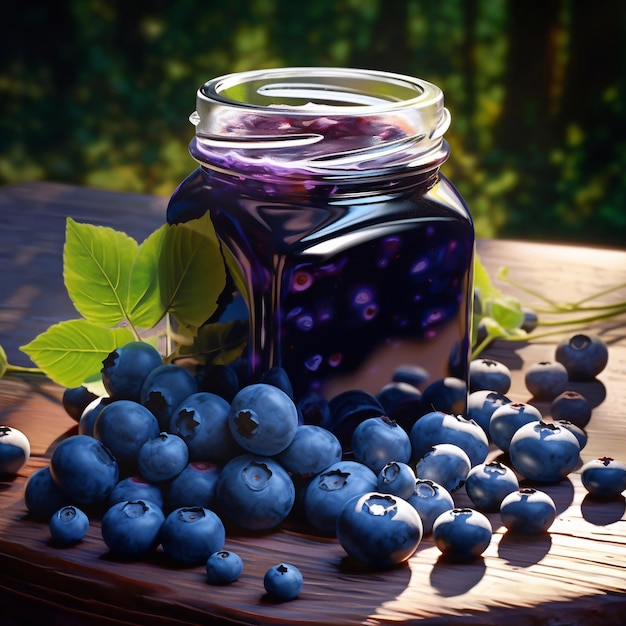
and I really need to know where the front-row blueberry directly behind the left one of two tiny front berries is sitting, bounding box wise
[160,506,226,566]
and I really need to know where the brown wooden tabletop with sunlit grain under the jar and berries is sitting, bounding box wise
[0,183,626,626]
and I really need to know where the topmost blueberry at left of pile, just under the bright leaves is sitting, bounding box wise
[101,341,163,402]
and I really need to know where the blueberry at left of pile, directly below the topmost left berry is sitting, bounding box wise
[93,400,160,473]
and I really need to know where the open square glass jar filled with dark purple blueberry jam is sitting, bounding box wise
[167,67,474,398]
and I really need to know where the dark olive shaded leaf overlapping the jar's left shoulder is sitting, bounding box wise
[159,214,226,328]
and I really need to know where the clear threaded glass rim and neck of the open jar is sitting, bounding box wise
[189,67,450,174]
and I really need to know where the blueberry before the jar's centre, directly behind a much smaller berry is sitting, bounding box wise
[352,416,411,474]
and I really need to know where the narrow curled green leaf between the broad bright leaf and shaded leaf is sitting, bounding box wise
[126,224,169,328]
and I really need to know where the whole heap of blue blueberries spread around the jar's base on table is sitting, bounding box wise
[11,335,626,600]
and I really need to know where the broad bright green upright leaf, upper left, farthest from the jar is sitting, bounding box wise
[63,218,139,326]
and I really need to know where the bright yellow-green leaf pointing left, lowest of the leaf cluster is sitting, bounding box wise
[20,320,133,387]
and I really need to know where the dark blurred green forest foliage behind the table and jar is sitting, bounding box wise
[0,0,626,247]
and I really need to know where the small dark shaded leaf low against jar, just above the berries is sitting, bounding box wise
[174,320,248,365]
